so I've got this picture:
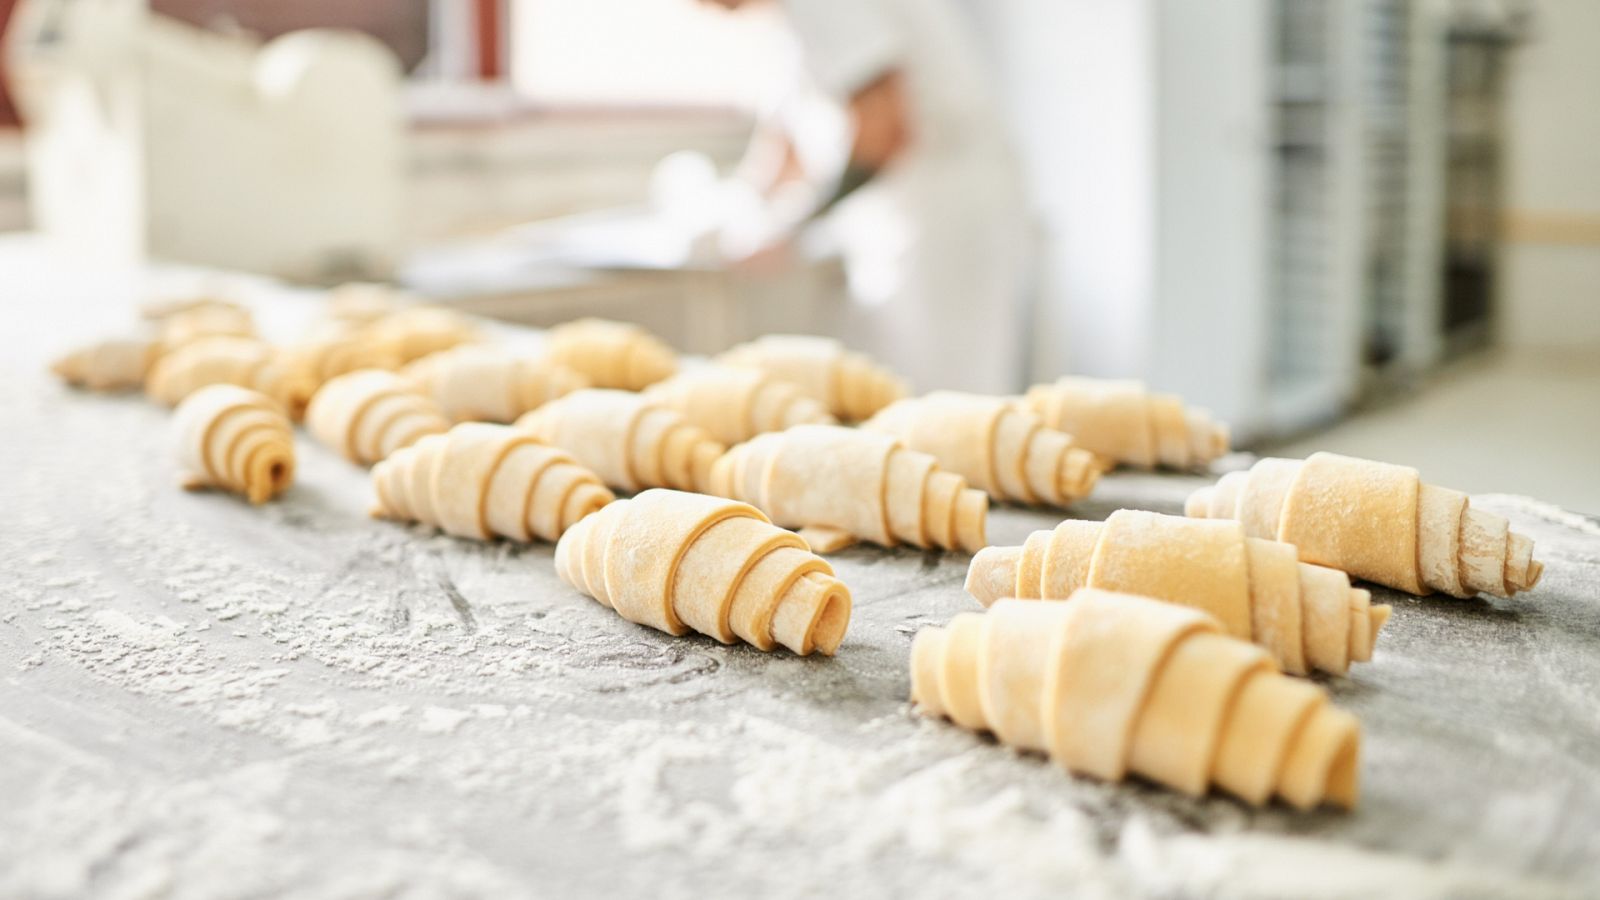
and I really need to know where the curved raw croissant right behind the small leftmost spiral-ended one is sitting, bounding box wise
[144,336,315,420]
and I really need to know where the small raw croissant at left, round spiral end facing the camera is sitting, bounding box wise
[173,384,294,504]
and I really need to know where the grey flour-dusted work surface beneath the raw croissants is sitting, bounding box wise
[0,240,1600,898]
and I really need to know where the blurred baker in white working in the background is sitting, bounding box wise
[709,0,1030,392]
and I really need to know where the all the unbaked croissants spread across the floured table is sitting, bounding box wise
[56,285,1542,809]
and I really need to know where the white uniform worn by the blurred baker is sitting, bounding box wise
[786,0,1030,392]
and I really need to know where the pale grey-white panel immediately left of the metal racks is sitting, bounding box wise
[1144,0,1272,436]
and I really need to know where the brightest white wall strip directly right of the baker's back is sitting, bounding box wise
[971,0,1155,380]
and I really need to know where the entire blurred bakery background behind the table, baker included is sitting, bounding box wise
[0,0,1600,512]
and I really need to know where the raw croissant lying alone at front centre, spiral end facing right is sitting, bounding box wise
[555,488,850,657]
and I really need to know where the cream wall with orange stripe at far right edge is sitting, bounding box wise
[1499,0,1600,348]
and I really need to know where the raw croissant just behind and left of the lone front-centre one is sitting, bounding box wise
[373,421,611,543]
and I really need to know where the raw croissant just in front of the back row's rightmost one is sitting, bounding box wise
[861,391,1099,506]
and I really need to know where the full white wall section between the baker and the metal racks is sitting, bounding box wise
[973,0,1270,434]
